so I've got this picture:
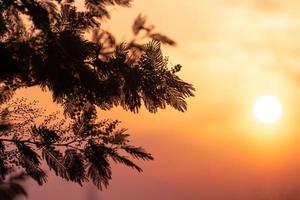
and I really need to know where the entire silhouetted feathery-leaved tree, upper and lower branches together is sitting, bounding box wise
[0,0,194,199]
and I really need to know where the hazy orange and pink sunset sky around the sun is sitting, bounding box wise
[18,0,300,200]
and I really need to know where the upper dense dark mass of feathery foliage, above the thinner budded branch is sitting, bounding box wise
[0,0,194,114]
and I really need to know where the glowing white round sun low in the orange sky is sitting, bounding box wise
[253,96,282,124]
